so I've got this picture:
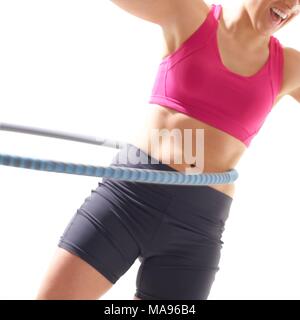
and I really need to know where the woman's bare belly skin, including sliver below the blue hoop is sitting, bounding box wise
[128,104,247,198]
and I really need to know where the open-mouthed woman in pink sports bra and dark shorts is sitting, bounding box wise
[37,0,300,300]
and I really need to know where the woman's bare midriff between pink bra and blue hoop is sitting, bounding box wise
[129,105,247,172]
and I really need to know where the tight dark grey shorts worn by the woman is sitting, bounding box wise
[58,145,232,300]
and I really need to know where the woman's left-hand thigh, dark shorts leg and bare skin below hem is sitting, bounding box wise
[39,145,176,299]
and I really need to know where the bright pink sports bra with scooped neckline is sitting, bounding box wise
[149,4,284,147]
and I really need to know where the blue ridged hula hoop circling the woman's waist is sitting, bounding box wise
[0,123,238,185]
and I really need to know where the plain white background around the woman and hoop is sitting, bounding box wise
[0,0,300,299]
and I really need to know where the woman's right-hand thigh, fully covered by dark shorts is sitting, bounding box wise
[135,182,232,300]
